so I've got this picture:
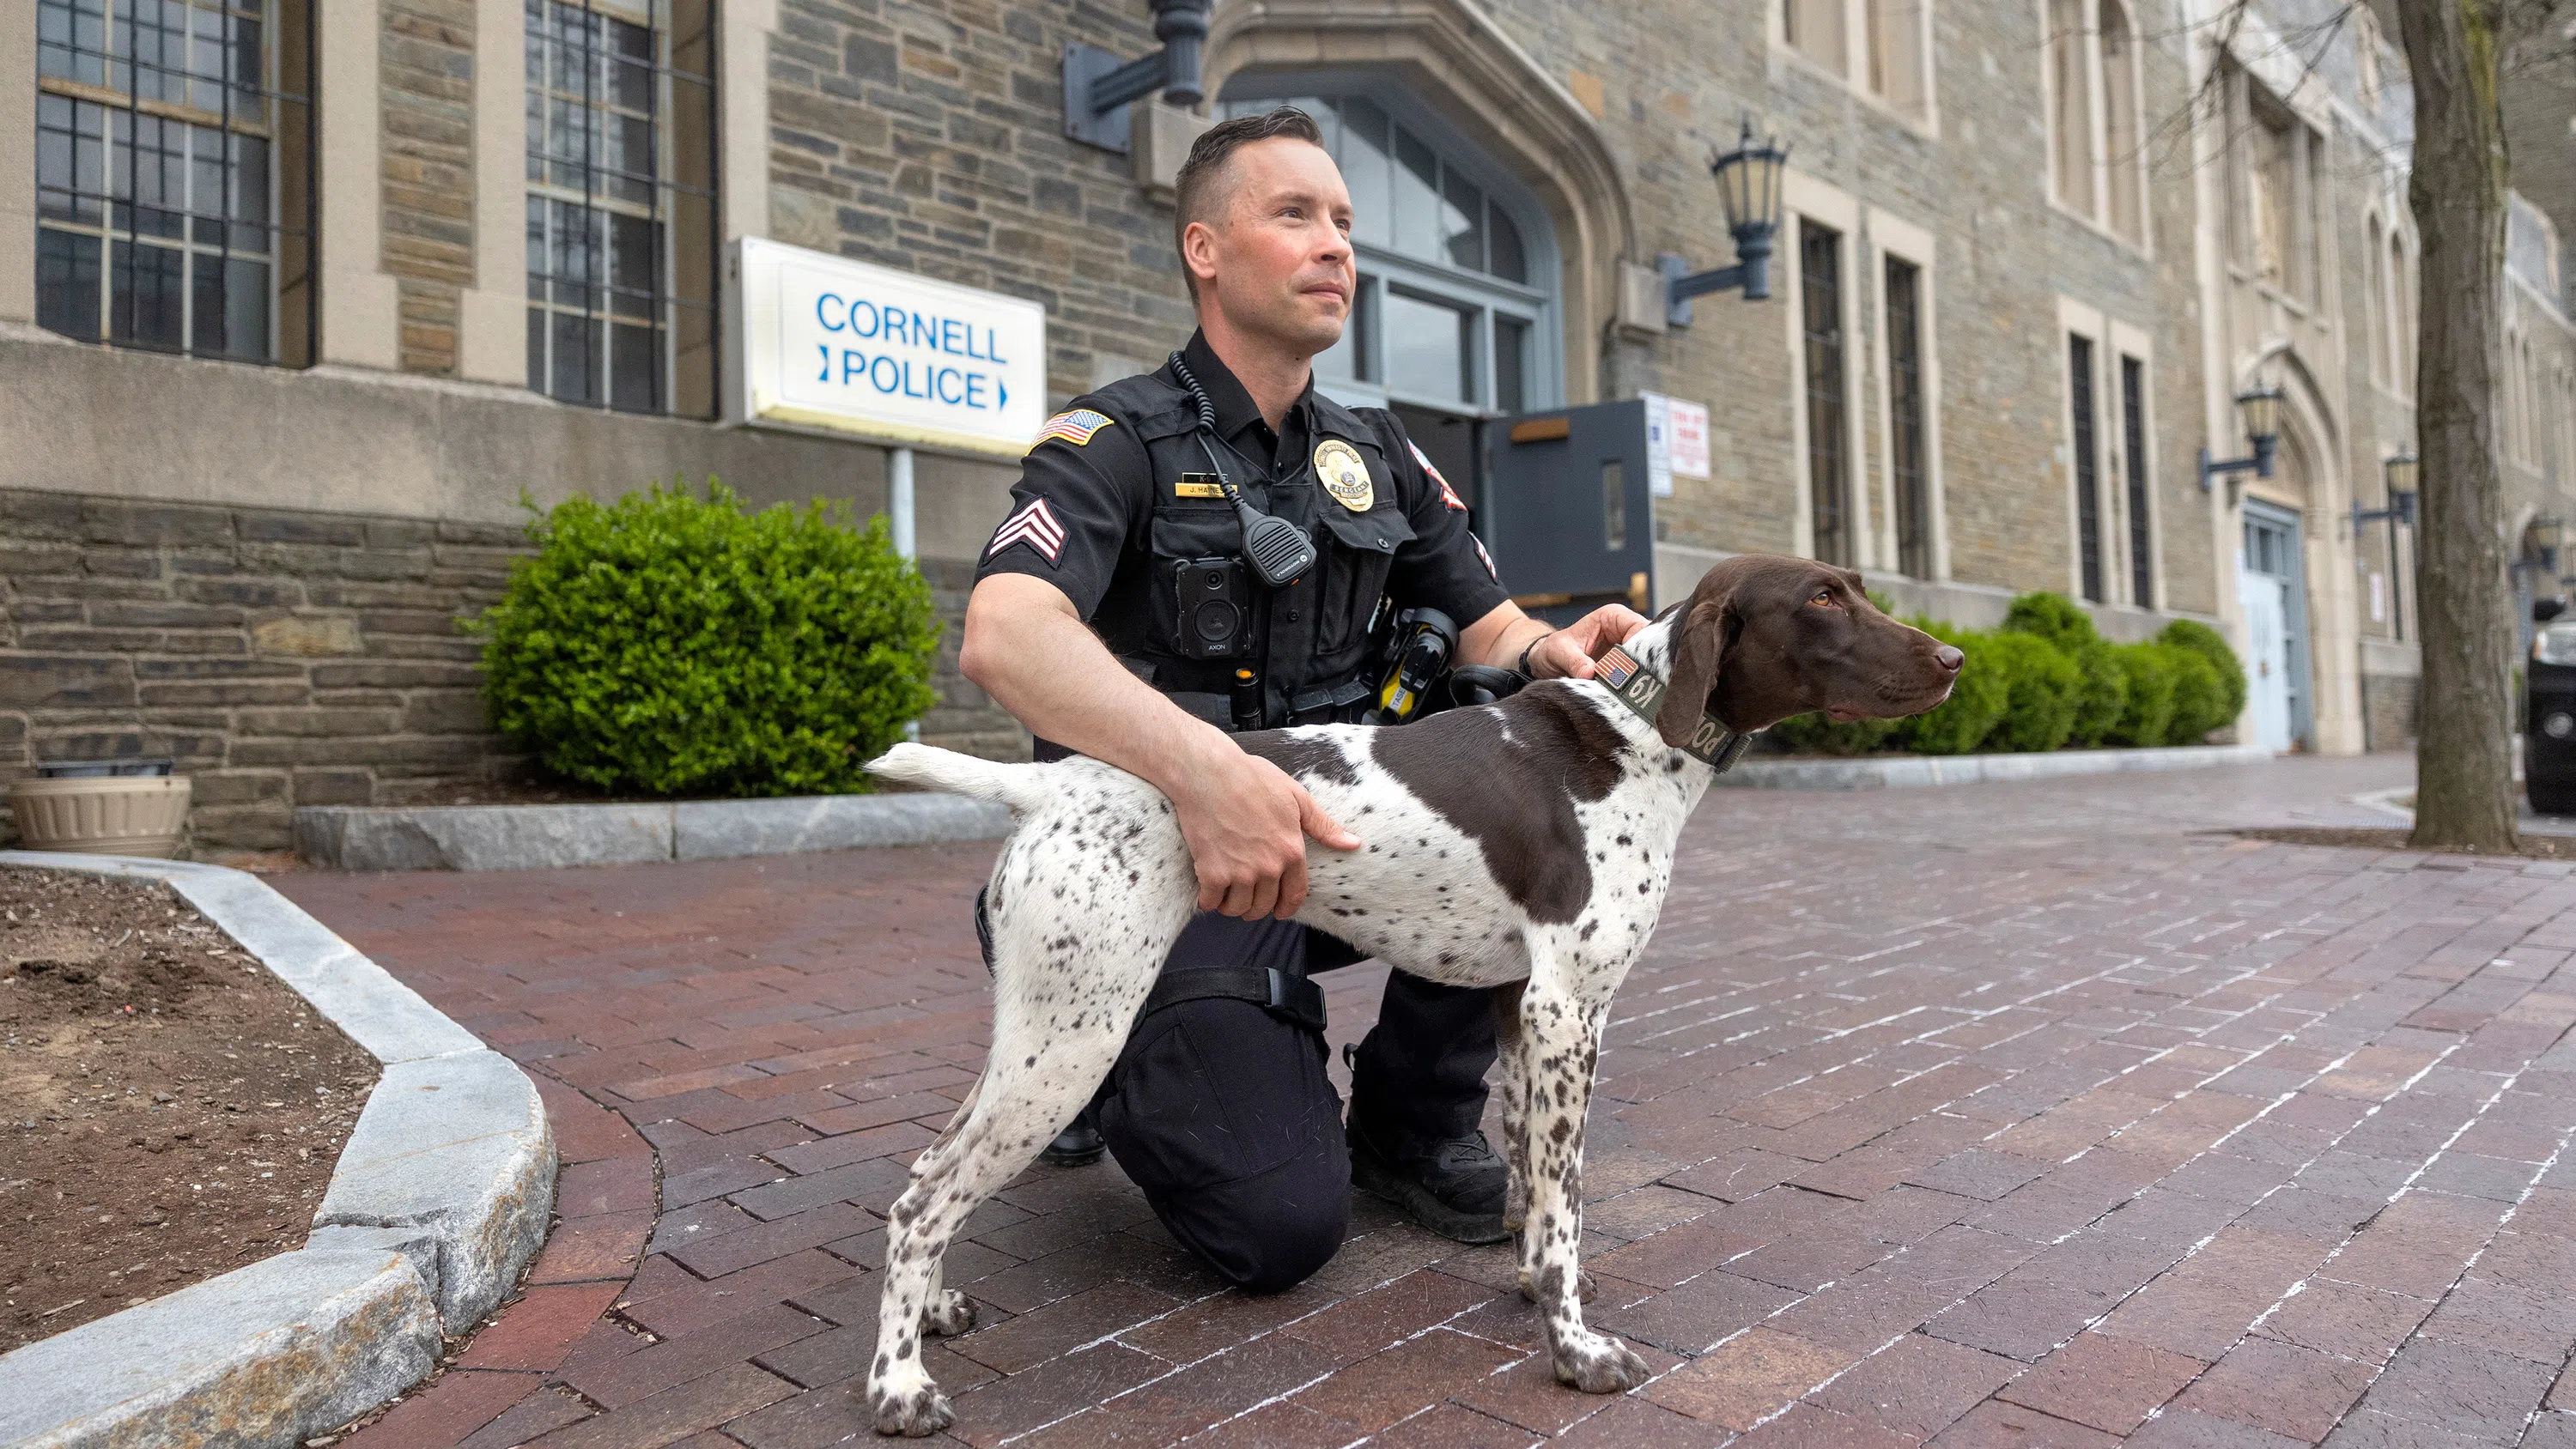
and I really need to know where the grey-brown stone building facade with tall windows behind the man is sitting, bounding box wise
[0,0,2568,846]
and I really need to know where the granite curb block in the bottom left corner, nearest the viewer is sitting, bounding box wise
[0,1248,438,1449]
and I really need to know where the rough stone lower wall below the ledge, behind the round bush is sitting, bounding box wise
[0,489,1028,849]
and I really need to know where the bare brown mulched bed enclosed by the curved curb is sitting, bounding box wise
[0,870,376,1354]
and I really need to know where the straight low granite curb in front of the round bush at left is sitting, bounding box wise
[294,792,1010,870]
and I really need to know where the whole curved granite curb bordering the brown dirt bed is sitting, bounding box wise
[0,849,556,1449]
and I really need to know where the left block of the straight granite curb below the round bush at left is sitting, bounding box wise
[296,805,670,870]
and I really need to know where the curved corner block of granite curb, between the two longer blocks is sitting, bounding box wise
[314,1050,554,1333]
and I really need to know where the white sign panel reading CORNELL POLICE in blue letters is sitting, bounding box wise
[734,237,1046,458]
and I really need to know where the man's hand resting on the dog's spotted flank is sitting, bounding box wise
[1172,736,1360,921]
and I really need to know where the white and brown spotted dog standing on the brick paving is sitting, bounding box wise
[868,556,1960,1434]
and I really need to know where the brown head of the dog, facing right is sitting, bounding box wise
[1654,554,1965,746]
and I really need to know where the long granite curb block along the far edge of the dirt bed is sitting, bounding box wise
[0,849,482,1063]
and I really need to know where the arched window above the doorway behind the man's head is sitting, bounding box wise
[1221,89,1564,415]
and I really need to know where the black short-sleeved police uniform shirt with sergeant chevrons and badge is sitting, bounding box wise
[976,335,1510,724]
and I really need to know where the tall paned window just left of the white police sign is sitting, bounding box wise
[528,0,716,417]
